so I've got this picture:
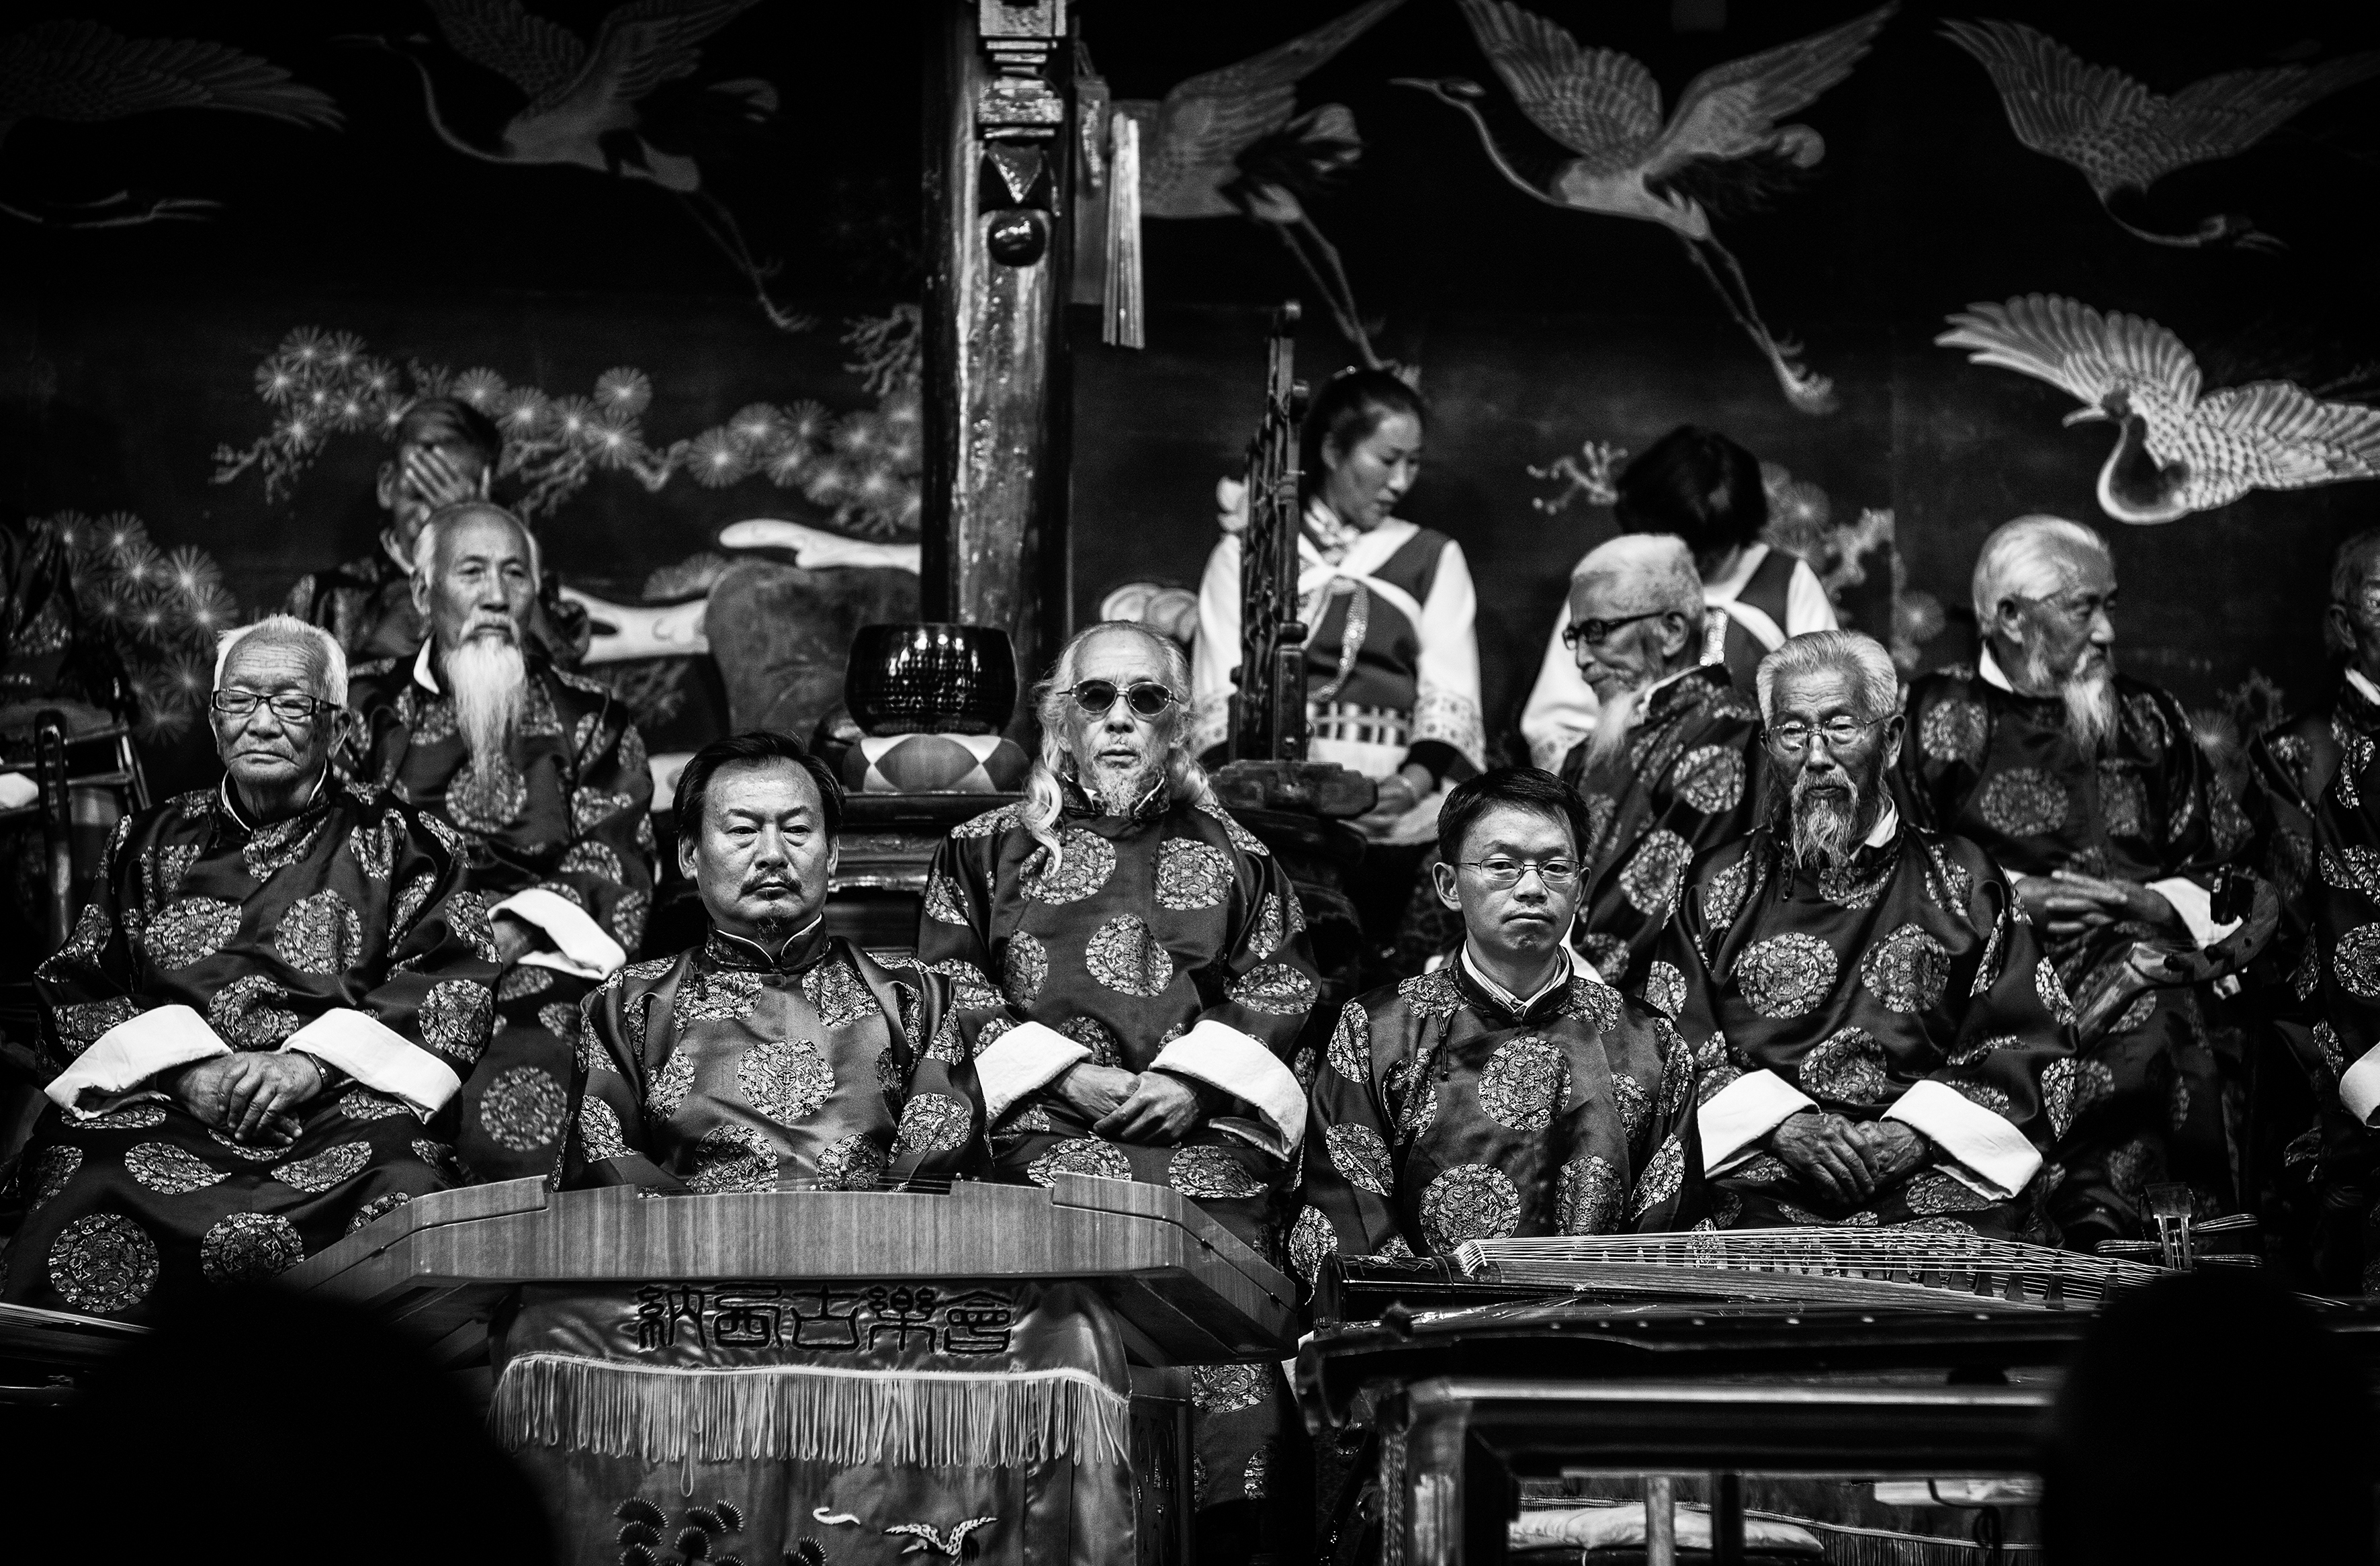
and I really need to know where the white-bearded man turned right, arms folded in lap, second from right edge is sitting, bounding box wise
[1899,517,2252,1250]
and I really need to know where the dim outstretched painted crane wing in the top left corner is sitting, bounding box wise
[0,21,341,133]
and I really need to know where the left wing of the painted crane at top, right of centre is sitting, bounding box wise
[1461,0,1661,174]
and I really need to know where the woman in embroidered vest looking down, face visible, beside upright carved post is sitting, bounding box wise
[1190,369,1483,947]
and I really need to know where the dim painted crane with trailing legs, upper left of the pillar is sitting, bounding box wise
[345,0,811,331]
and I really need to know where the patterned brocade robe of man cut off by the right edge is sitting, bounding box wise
[2249,674,2380,1293]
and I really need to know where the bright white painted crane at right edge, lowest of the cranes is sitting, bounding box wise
[1935,293,2380,523]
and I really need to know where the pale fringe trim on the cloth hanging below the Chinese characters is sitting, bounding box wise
[488,1354,1131,1469]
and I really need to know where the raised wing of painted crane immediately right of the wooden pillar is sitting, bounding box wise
[1143,0,1404,216]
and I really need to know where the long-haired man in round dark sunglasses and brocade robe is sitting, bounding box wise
[919,623,1316,1559]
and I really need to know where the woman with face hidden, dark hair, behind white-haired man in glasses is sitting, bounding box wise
[1521,424,1835,771]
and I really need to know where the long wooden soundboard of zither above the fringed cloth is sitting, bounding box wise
[281,1173,1297,1366]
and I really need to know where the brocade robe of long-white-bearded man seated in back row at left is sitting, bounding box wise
[347,645,654,1180]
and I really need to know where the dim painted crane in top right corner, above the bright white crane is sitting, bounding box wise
[1942,21,2380,250]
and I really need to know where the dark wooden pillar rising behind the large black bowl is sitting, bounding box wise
[924,0,1073,681]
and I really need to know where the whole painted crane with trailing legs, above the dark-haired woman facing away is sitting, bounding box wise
[1399,0,1894,414]
